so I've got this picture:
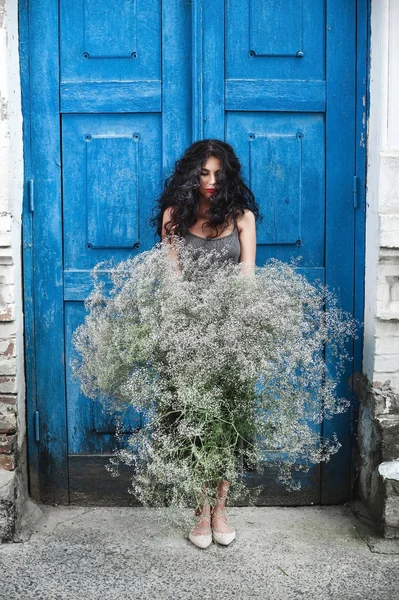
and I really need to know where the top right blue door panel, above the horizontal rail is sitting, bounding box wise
[225,0,325,80]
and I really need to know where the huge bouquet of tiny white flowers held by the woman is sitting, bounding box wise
[71,238,356,524]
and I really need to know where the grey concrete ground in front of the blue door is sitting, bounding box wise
[0,502,399,600]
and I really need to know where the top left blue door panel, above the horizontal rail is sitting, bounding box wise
[60,0,162,83]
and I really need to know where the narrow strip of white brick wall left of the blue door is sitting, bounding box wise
[0,0,26,468]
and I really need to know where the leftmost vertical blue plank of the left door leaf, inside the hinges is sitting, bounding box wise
[25,0,68,504]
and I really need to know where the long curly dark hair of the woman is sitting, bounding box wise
[149,139,262,237]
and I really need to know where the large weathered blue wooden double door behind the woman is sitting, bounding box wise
[23,0,366,504]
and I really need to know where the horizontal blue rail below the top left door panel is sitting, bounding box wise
[60,81,161,113]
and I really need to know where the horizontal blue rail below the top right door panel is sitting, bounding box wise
[226,79,326,112]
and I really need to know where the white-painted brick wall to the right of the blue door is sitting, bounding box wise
[363,0,399,391]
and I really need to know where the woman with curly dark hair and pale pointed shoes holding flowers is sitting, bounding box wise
[151,139,259,548]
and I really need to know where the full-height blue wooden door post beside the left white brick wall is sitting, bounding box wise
[19,0,69,504]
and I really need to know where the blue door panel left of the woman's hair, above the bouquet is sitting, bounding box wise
[62,113,162,264]
